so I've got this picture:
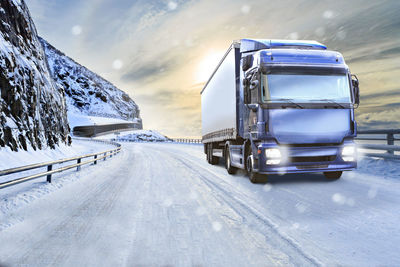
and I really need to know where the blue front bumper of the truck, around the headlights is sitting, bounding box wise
[255,142,357,174]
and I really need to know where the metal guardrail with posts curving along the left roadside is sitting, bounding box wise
[0,141,121,189]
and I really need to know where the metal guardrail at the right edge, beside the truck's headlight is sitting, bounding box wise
[356,129,400,160]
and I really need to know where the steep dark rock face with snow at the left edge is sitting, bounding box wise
[0,0,71,151]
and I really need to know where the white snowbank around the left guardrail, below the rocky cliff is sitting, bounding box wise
[0,139,116,230]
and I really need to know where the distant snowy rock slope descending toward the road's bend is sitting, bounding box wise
[40,39,141,125]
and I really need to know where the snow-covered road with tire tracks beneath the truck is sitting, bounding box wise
[0,143,400,266]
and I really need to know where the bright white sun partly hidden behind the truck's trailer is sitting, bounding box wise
[195,51,224,83]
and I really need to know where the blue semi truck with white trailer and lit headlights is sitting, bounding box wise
[201,39,360,183]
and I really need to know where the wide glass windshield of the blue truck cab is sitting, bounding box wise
[262,74,351,103]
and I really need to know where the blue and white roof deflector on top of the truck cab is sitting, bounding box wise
[239,39,327,53]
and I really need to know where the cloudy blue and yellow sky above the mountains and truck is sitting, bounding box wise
[26,0,400,137]
